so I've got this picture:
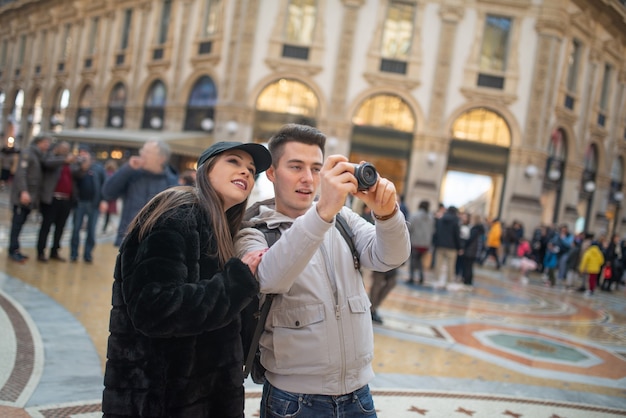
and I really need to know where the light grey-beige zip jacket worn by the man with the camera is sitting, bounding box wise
[235,202,410,395]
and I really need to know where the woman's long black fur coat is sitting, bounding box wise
[102,207,258,418]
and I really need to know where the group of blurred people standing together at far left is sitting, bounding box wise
[2,135,195,263]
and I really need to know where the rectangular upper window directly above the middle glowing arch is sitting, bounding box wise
[382,2,415,60]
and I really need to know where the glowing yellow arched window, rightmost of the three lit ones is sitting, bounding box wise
[452,108,511,147]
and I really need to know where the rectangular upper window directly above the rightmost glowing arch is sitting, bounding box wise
[480,15,511,72]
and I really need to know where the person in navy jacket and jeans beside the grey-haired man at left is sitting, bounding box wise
[70,145,107,263]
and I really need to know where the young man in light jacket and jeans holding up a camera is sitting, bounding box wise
[236,124,410,418]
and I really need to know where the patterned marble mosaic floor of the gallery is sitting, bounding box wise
[0,188,626,418]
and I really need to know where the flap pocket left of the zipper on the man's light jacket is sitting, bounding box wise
[272,304,330,370]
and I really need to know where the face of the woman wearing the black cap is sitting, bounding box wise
[209,149,256,211]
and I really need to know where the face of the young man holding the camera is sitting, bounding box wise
[267,142,324,218]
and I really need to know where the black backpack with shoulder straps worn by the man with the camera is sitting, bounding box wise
[241,213,361,384]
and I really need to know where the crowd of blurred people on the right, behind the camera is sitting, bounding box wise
[407,200,626,295]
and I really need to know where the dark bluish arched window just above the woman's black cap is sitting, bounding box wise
[185,75,217,132]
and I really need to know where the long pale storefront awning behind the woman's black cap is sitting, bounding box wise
[52,128,213,158]
